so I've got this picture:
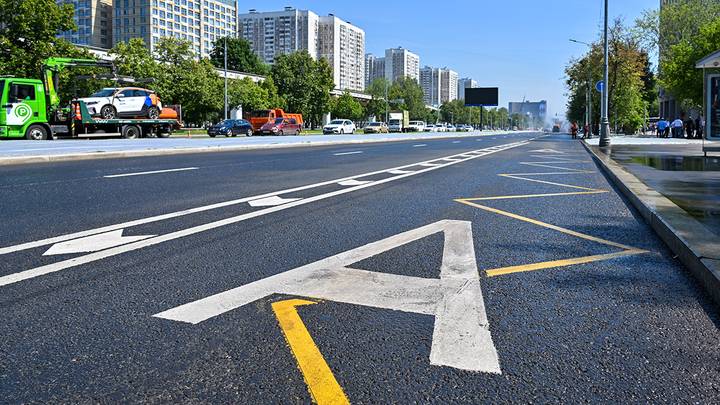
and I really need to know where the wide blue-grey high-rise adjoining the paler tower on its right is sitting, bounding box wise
[238,7,320,64]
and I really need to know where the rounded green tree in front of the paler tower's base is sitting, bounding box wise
[271,51,335,126]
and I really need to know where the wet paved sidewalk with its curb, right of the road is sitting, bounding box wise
[585,137,720,304]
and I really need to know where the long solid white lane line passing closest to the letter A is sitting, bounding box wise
[0,141,528,287]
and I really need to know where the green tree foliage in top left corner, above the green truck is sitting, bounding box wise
[0,0,87,77]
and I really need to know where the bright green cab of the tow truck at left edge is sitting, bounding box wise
[0,77,50,140]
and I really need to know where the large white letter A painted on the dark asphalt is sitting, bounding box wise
[154,220,501,374]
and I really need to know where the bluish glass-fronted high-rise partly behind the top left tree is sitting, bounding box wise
[57,0,113,49]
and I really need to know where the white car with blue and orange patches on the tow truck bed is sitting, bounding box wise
[79,87,162,120]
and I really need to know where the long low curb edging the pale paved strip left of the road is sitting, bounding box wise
[0,132,524,166]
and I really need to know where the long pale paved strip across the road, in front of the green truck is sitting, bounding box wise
[0,131,520,166]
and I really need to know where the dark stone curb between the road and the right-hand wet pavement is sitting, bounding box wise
[582,141,720,305]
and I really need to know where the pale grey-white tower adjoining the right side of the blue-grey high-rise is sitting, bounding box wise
[318,14,365,91]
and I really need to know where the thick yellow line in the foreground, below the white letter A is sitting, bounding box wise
[272,299,350,405]
